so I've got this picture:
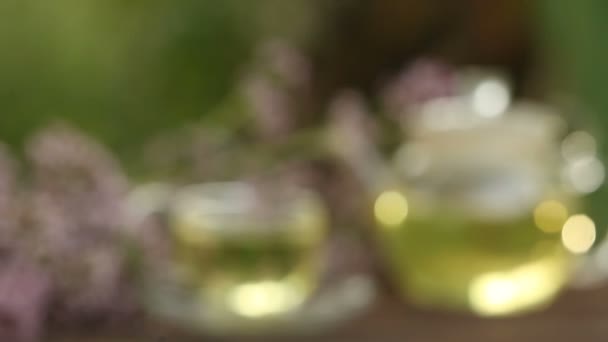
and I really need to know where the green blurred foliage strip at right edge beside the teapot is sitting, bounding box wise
[539,0,608,239]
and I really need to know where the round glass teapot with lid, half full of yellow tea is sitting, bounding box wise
[374,74,604,316]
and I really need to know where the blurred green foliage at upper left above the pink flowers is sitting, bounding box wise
[0,0,320,155]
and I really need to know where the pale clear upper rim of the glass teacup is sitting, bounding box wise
[168,181,327,233]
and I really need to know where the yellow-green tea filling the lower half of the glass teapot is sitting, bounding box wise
[376,191,571,316]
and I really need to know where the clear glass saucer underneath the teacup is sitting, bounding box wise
[144,236,377,336]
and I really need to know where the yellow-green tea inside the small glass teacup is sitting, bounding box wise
[171,186,325,318]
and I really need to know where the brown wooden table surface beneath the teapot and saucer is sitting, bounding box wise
[48,287,608,342]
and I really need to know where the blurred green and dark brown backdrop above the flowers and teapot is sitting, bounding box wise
[0,0,603,150]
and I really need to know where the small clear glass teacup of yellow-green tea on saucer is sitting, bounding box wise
[134,182,327,331]
